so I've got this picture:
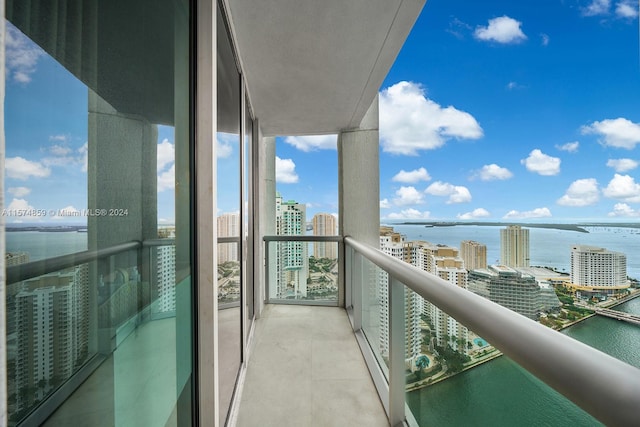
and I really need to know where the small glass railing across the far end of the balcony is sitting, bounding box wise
[264,236,342,305]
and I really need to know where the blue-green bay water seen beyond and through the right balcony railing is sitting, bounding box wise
[394,225,640,427]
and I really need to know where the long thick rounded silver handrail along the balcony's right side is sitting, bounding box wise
[344,237,640,426]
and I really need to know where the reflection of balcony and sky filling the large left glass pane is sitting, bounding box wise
[5,0,193,426]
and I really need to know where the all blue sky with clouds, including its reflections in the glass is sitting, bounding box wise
[5,0,640,226]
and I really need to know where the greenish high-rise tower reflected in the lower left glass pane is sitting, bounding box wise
[14,264,89,410]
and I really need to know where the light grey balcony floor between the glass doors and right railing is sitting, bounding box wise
[237,304,389,427]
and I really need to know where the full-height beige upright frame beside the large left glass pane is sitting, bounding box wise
[195,0,220,426]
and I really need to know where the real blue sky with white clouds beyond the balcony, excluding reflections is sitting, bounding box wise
[277,0,640,221]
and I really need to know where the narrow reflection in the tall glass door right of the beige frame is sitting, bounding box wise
[216,2,243,424]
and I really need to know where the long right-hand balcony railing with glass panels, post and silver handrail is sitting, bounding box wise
[344,237,640,426]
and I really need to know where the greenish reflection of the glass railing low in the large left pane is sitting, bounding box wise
[6,239,177,426]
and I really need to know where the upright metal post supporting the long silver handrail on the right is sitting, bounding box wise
[389,277,405,426]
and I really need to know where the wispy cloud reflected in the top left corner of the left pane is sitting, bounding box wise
[5,22,44,84]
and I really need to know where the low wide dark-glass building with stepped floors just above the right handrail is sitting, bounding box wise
[468,265,560,319]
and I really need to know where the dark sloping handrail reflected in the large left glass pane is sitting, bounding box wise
[6,240,142,284]
